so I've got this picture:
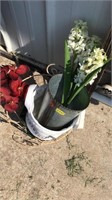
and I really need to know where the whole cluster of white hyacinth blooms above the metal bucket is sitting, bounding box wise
[67,20,107,87]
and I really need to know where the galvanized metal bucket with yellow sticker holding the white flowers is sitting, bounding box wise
[34,74,89,130]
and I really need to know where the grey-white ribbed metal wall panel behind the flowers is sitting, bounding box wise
[1,0,111,64]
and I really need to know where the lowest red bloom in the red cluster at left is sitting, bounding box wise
[4,97,19,112]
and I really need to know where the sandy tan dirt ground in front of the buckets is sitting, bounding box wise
[0,54,112,200]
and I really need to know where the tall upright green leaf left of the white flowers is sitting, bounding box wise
[61,41,72,104]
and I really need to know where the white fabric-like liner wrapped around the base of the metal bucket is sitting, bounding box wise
[25,84,85,140]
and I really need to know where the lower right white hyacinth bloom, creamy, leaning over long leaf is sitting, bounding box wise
[74,48,107,87]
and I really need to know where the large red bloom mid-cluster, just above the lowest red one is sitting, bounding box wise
[9,79,27,97]
